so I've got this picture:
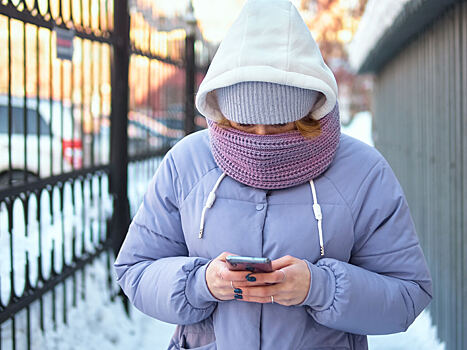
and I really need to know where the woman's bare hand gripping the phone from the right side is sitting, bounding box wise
[229,255,311,306]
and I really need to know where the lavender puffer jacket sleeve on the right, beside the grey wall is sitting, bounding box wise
[300,159,432,334]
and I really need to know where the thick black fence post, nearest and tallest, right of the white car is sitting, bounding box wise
[110,0,130,255]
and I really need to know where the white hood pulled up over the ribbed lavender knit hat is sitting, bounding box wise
[195,0,337,121]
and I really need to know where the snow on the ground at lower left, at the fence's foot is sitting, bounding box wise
[1,254,175,350]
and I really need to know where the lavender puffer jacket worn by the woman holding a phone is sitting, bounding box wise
[114,130,432,350]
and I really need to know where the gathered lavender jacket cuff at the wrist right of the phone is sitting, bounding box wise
[298,259,336,311]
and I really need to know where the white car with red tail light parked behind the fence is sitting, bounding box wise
[0,95,83,188]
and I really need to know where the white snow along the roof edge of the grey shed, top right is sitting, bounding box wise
[348,0,410,70]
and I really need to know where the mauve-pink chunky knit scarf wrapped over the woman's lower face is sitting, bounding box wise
[208,104,340,189]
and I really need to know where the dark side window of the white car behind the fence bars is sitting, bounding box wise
[0,106,49,135]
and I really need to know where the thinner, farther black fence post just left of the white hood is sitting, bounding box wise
[185,27,196,135]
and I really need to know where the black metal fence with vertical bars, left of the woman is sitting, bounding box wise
[0,0,208,349]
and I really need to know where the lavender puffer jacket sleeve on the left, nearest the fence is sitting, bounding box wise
[114,153,217,324]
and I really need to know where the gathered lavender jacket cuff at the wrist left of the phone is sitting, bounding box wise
[185,261,219,309]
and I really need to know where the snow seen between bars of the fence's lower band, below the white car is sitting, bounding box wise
[0,175,113,305]
